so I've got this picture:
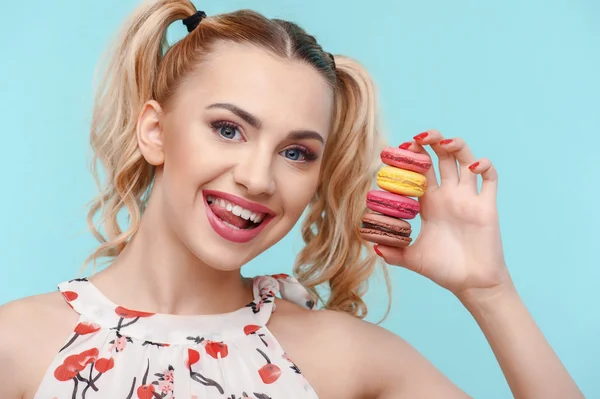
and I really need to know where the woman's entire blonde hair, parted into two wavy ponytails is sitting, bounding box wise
[86,0,390,318]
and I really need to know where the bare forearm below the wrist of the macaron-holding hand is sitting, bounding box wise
[460,286,584,399]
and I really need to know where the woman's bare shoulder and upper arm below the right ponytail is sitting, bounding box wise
[270,305,468,398]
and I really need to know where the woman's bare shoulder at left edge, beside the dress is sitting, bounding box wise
[0,291,78,399]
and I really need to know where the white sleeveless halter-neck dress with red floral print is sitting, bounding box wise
[34,274,317,399]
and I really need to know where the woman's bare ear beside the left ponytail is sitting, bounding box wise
[136,100,165,166]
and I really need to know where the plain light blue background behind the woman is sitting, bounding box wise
[0,0,600,398]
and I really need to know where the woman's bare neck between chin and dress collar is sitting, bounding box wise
[90,197,253,315]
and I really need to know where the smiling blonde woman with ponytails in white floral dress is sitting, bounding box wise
[0,0,582,399]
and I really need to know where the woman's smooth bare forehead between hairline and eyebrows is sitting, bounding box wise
[183,43,333,135]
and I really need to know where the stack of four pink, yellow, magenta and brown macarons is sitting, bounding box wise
[360,147,431,248]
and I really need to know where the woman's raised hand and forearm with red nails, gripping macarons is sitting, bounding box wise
[368,134,583,399]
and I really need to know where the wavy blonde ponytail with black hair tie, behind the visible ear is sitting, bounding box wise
[84,0,196,269]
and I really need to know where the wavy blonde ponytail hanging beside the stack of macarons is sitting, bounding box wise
[294,56,391,320]
